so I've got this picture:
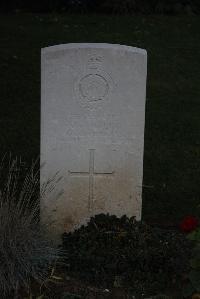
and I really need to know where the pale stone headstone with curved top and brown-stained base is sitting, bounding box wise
[41,43,147,241]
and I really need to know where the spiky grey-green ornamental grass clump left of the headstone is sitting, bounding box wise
[0,156,61,298]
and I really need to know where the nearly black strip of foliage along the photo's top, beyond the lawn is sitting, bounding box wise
[0,0,200,14]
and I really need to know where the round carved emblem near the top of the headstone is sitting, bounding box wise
[79,74,109,102]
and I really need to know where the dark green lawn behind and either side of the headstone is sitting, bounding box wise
[0,14,200,223]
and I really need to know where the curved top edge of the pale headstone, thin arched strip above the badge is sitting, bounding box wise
[42,43,147,55]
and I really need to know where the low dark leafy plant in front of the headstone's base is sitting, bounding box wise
[63,214,191,294]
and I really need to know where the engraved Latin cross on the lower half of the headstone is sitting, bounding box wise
[69,149,114,212]
